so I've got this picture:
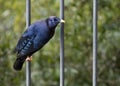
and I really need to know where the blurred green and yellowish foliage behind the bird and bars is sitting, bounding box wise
[0,0,120,86]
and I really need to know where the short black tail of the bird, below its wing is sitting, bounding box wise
[13,56,27,71]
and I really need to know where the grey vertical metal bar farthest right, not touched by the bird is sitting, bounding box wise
[93,0,98,86]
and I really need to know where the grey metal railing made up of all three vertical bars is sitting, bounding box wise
[26,0,97,86]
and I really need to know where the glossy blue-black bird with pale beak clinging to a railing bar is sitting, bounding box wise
[13,16,64,71]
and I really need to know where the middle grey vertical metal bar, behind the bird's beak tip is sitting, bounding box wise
[60,0,64,86]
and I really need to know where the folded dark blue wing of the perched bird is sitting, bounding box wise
[15,27,36,57]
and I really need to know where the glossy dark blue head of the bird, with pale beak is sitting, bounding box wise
[46,16,65,29]
